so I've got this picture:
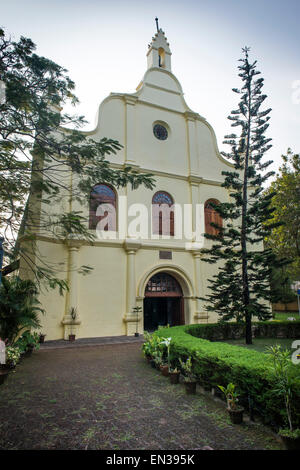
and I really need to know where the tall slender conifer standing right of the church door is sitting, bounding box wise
[202,47,283,344]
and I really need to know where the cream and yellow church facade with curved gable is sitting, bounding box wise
[22,29,236,340]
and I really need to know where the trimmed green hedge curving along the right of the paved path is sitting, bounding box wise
[155,325,300,429]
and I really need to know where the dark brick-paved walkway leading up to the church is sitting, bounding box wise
[0,344,282,450]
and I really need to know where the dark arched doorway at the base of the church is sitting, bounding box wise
[144,272,184,331]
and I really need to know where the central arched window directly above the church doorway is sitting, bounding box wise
[152,191,174,236]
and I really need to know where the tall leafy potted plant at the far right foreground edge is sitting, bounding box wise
[267,345,300,450]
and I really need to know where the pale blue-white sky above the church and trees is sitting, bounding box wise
[0,0,300,181]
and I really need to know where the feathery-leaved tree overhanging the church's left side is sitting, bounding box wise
[0,28,154,290]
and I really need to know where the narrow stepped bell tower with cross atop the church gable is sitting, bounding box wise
[147,18,172,72]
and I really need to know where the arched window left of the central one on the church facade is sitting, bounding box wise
[89,184,117,231]
